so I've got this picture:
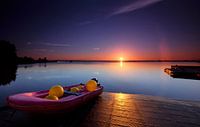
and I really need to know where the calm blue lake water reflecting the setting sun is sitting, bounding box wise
[0,62,200,106]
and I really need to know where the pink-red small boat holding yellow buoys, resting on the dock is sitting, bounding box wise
[7,85,103,113]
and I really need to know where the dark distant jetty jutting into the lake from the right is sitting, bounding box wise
[164,65,200,80]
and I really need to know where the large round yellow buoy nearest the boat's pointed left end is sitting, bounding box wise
[49,85,64,97]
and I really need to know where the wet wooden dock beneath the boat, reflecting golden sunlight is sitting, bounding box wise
[0,92,200,127]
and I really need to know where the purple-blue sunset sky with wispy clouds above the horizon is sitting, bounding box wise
[0,0,200,60]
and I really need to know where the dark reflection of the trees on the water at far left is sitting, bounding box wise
[0,64,17,85]
